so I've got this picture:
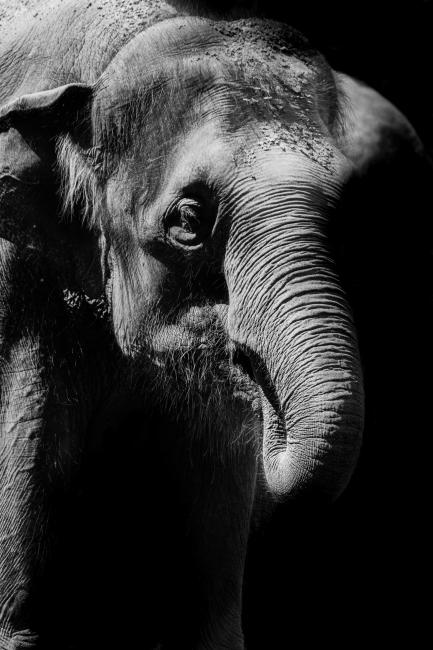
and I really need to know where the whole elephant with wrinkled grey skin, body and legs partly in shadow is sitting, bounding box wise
[0,0,426,650]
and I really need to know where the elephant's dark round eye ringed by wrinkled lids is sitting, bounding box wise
[165,198,209,248]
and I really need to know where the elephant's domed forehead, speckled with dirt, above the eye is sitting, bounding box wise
[94,18,338,199]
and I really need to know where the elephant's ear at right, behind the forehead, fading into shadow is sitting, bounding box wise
[336,73,425,173]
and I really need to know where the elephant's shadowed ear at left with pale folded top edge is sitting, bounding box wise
[0,84,102,292]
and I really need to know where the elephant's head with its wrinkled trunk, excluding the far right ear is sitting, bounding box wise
[0,18,363,498]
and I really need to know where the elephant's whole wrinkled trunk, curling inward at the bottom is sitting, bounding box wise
[226,154,363,499]
